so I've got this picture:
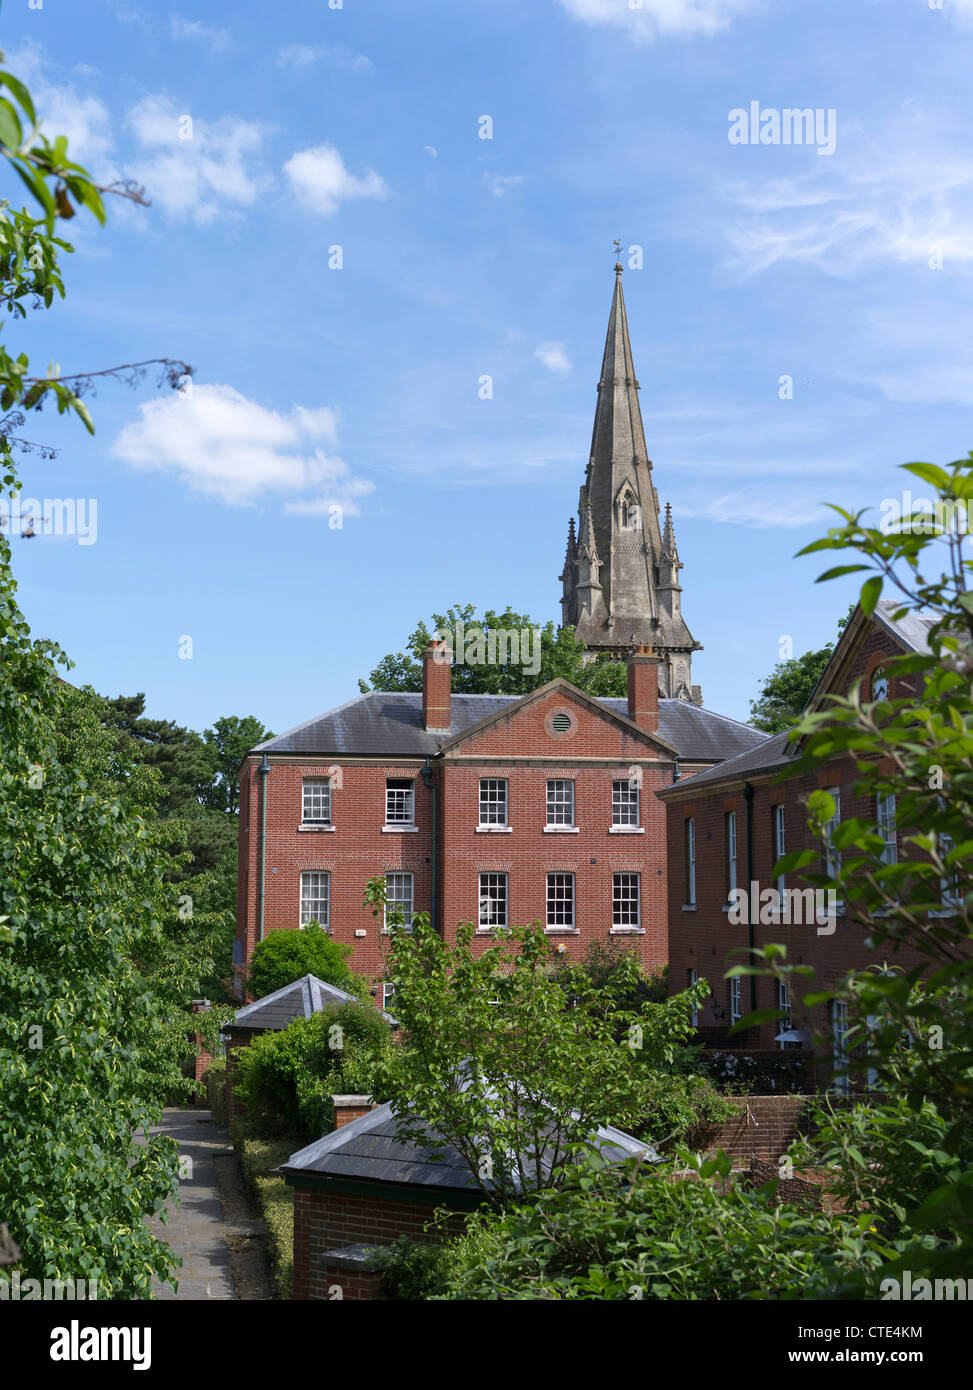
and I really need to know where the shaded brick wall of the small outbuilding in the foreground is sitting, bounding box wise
[293,1186,466,1300]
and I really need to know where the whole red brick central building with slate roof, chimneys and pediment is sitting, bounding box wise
[238,644,765,1002]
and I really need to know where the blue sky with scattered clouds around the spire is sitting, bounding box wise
[7,0,973,731]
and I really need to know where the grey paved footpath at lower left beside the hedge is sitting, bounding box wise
[137,1105,236,1300]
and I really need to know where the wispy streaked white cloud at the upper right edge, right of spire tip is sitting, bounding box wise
[727,113,973,275]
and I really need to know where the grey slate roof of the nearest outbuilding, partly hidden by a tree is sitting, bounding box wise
[278,1104,656,1191]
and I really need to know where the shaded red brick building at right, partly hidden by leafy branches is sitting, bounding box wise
[659,603,927,1073]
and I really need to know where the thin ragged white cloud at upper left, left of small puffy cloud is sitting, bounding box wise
[128,95,271,224]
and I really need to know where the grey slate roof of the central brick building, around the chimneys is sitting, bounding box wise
[252,691,767,763]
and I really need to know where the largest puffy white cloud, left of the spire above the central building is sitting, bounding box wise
[111,385,374,516]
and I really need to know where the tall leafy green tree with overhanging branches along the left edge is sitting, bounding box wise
[0,51,198,1298]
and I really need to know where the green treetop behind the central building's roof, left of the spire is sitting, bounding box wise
[359,603,628,696]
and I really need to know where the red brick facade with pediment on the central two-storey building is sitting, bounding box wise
[238,691,686,1002]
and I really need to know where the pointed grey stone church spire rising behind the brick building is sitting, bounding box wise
[560,265,702,705]
